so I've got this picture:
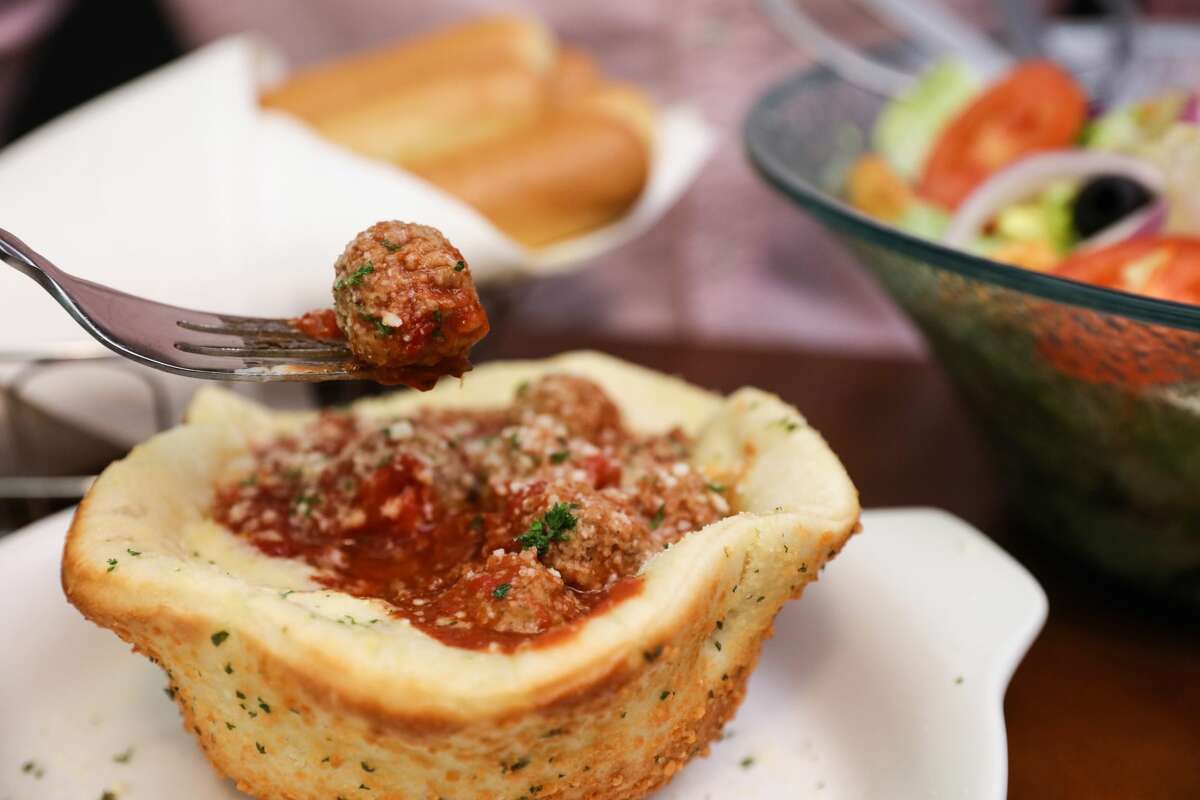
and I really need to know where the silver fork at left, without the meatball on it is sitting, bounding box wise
[0,229,371,381]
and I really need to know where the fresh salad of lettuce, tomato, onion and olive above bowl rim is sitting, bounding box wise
[845,61,1200,305]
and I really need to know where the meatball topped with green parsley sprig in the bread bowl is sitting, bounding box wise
[510,482,654,591]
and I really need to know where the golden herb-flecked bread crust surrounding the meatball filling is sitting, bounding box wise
[62,354,858,800]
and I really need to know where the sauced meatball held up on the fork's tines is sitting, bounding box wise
[334,222,488,383]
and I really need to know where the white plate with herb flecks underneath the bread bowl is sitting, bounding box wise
[0,509,1046,800]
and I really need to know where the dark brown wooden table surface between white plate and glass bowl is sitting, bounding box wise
[480,332,1200,800]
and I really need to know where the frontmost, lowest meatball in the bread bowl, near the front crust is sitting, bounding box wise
[430,551,584,634]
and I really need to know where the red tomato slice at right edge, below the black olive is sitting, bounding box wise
[1054,236,1200,306]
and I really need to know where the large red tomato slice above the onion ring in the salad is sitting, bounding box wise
[918,61,1087,209]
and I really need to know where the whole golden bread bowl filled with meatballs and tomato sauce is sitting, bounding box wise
[62,353,859,800]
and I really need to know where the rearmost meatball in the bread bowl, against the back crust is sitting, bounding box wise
[512,374,620,443]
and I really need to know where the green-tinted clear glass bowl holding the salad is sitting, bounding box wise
[743,42,1200,610]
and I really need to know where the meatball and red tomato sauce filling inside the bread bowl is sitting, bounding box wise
[212,379,730,651]
